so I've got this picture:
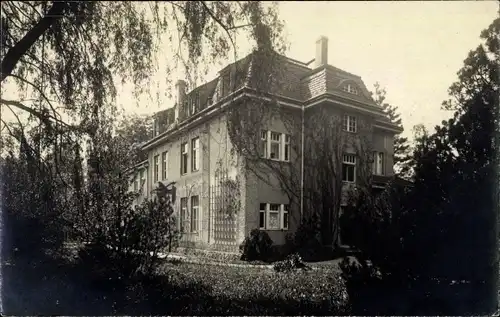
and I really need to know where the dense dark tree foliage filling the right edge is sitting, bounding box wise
[340,19,500,314]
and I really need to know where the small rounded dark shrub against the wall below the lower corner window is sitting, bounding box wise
[240,229,273,261]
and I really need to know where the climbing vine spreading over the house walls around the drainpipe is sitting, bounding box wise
[228,92,372,251]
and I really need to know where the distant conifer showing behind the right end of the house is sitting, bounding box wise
[374,83,411,178]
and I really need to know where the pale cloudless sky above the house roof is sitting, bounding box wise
[116,1,498,137]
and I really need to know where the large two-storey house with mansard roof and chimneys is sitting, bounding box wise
[131,37,402,251]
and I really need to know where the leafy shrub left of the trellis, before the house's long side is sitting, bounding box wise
[81,180,183,280]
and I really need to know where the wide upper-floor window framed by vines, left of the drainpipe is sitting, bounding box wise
[260,130,290,162]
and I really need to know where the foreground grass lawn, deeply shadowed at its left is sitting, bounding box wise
[2,246,347,315]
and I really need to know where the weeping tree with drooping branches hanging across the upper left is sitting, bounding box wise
[0,1,283,188]
